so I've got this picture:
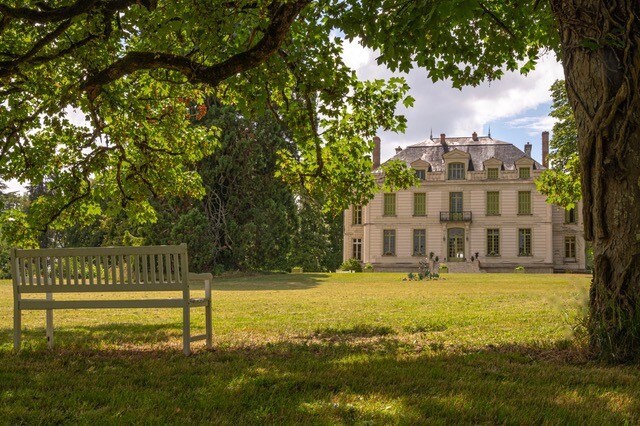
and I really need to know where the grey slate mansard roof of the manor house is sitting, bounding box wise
[390,136,545,172]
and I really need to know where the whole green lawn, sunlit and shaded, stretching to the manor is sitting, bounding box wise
[0,273,640,424]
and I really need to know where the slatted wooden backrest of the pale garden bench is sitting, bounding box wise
[11,244,189,293]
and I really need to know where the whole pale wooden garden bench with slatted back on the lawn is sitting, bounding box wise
[11,244,213,355]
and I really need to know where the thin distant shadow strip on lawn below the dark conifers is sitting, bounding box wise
[212,273,329,291]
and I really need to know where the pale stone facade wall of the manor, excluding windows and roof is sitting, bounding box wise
[344,170,585,272]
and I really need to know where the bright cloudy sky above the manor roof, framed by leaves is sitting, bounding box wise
[343,40,563,162]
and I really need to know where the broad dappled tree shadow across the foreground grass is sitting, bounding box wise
[0,324,640,424]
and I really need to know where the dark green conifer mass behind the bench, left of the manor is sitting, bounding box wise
[145,103,296,270]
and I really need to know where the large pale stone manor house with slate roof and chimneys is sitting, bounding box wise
[344,132,586,272]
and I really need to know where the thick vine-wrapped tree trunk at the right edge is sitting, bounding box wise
[551,0,640,362]
